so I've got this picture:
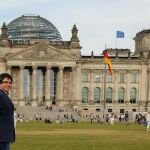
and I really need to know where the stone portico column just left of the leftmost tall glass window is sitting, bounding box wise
[19,66,25,106]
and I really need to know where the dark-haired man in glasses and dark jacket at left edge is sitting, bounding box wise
[0,73,15,150]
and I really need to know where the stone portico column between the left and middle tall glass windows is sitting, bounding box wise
[31,66,38,106]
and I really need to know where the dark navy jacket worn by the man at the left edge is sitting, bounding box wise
[0,90,15,143]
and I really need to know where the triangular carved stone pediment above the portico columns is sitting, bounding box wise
[6,43,78,61]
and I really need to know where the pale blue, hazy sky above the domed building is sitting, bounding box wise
[0,0,150,55]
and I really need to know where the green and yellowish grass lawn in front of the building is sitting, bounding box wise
[11,122,150,150]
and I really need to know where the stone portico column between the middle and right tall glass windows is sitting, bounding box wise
[45,66,52,106]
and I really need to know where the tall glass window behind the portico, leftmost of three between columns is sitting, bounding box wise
[23,69,31,98]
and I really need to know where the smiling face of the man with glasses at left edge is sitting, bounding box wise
[0,78,12,92]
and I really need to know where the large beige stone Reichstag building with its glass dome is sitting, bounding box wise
[0,15,150,113]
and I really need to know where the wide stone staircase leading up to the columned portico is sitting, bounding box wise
[16,105,80,120]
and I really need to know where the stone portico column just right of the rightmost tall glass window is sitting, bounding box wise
[59,66,64,100]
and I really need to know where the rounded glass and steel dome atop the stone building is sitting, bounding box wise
[7,15,62,41]
